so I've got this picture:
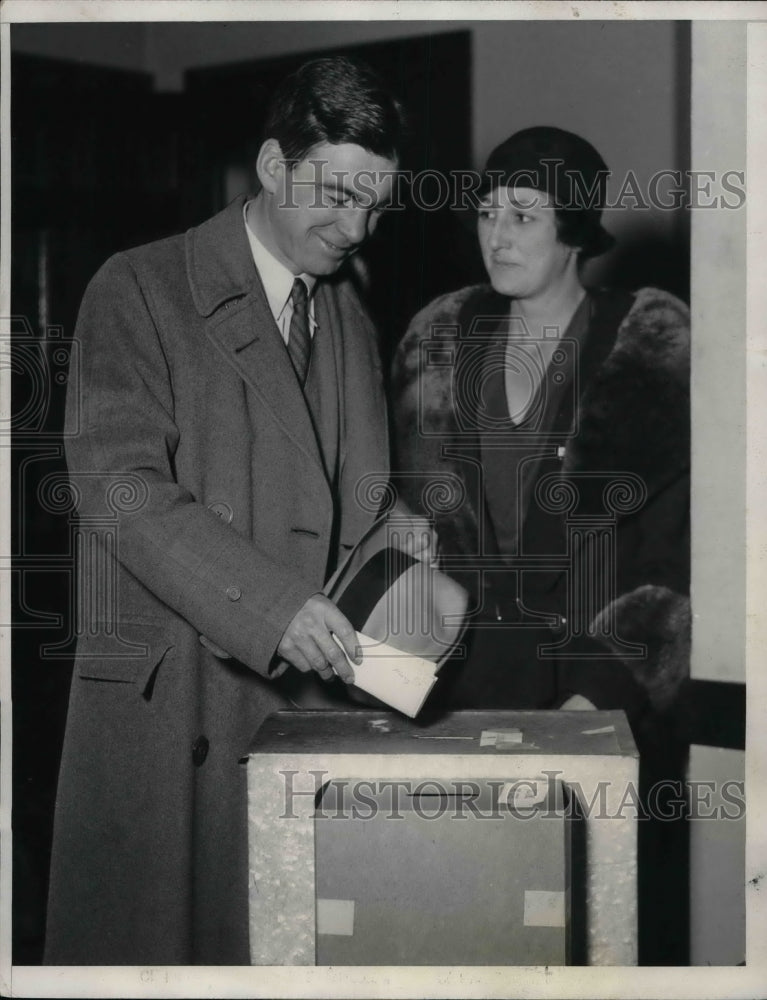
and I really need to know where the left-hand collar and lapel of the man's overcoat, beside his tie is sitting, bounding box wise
[186,197,327,482]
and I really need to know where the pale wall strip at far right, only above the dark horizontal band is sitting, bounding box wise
[692,22,746,682]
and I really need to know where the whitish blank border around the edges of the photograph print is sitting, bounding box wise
[0,0,767,1000]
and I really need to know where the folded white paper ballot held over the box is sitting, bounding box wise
[336,632,437,719]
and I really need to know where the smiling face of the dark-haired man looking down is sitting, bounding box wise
[262,143,397,277]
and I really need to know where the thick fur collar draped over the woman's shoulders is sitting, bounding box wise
[392,285,690,492]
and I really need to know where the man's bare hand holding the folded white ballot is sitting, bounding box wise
[277,594,362,684]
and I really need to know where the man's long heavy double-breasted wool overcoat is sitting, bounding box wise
[46,193,388,965]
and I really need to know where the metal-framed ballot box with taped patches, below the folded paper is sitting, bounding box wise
[247,710,638,966]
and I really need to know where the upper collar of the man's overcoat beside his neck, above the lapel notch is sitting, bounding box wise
[186,195,258,316]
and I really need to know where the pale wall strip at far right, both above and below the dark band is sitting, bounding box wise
[689,15,746,965]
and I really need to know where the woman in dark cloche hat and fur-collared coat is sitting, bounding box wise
[394,127,689,736]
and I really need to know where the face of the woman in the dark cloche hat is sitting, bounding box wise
[477,187,576,299]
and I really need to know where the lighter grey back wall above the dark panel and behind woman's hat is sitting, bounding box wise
[142,21,677,165]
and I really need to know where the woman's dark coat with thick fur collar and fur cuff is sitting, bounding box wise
[392,286,690,735]
